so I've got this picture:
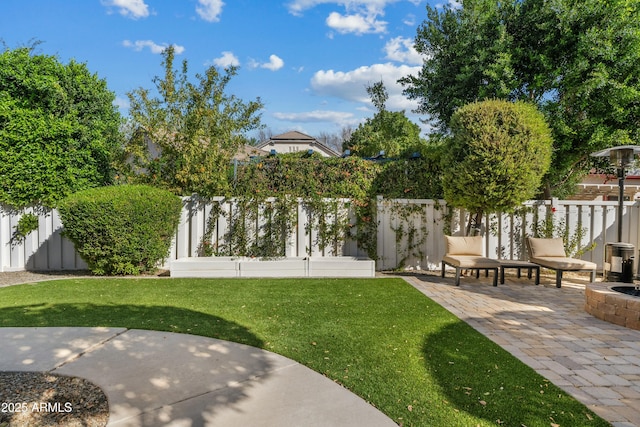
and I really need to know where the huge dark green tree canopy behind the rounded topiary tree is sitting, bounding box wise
[401,0,640,196]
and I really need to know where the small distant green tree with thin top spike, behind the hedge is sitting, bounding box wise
[343,82,425,157]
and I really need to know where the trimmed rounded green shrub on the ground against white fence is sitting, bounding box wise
[58,185,182,275]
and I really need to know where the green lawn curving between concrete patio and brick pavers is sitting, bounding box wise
[0,278,609,427]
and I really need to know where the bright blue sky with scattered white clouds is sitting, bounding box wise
[0,0,447,140]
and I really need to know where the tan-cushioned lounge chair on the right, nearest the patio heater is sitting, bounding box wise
[527,237,598,288]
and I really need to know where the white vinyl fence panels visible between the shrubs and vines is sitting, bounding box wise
[0,197,640,271]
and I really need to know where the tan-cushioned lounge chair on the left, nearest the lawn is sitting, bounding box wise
[442,236,500,286]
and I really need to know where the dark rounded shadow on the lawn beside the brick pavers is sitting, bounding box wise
[423,322,609,427]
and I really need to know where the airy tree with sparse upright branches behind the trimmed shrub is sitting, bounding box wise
[123,47,262,197]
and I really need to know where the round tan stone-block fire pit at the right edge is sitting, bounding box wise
[585,282,640,330]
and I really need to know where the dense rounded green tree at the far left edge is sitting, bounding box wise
[0,48,121,208]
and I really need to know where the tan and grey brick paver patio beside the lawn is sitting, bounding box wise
[402,272,640,427]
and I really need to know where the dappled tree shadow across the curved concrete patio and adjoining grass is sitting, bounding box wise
[0,304,274,425]
